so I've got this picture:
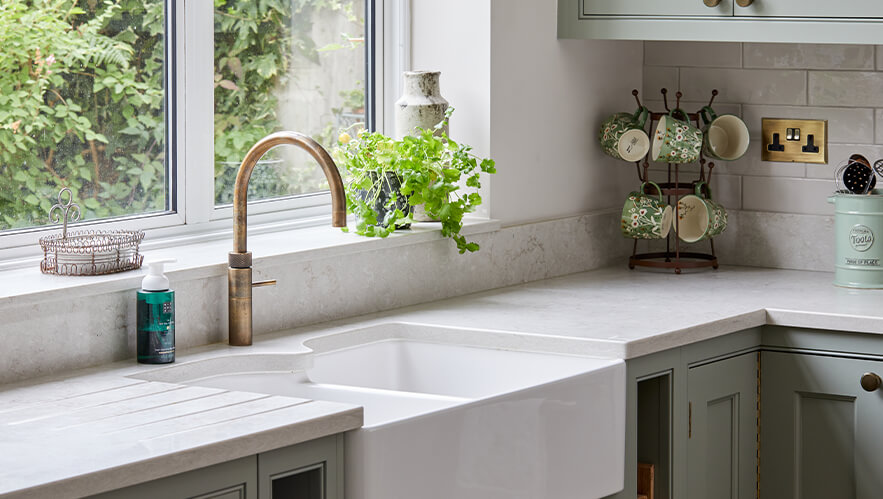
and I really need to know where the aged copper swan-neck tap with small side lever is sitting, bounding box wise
[227,132,346,346]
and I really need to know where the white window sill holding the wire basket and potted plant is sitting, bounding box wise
[0,218,500,307]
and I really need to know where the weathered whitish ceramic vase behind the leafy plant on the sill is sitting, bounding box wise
[395,71,448,140]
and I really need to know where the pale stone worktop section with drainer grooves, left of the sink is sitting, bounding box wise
[0,370,362,499]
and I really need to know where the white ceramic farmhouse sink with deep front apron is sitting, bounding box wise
[135,324,625,499]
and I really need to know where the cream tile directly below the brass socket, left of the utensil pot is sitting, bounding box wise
[742,176,834,215]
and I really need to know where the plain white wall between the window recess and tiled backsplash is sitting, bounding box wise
[491,0,643,224]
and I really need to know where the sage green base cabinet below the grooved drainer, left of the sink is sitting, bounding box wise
[92,435,344,499]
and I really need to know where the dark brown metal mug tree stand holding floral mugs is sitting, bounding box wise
[629,88,718,274]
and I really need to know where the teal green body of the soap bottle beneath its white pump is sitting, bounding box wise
[136,291,175,364]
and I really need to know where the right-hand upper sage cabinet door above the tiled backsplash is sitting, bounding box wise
[735,0,883,19]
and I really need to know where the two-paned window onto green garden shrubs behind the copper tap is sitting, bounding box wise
[0,0,382,259]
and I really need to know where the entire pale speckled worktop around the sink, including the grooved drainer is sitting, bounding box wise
[0,267,883,497]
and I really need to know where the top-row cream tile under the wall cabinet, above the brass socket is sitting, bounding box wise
[743,43,874,70]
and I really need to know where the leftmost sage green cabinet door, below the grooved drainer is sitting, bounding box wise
[92,456,258,499]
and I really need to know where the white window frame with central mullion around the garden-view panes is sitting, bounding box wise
[0,0,402,270]
